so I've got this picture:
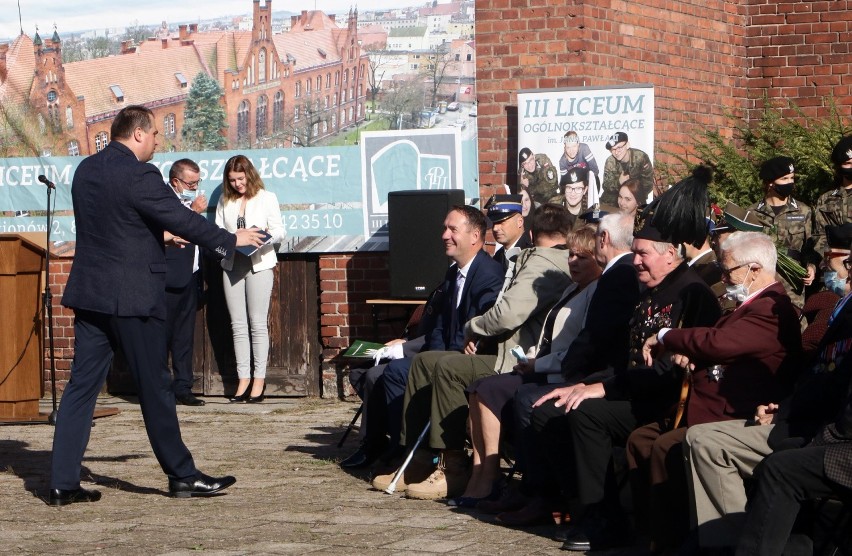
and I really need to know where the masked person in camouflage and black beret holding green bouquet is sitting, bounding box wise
[749,156,819,309]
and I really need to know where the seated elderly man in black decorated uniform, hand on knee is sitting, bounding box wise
[532,208,720,551]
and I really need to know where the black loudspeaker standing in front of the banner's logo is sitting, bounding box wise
[388,189,464,299]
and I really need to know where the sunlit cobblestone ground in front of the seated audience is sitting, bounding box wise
[0,397,624,555]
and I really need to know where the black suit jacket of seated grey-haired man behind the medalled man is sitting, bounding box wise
[562,253,640,382]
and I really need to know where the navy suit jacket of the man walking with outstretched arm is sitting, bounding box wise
[62,141,236,319]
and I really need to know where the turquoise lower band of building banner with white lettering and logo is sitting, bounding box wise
[0,127,472,253]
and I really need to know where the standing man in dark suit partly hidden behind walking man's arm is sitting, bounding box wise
[164,158,207,406]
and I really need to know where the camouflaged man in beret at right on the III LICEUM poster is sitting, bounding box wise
[600,131,654,206]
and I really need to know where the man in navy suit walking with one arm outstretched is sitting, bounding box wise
[49,102,260,506]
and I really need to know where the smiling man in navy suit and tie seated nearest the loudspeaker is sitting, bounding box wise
[341,206,503,468]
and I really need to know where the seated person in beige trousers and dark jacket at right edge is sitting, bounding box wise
[684,224,852,553]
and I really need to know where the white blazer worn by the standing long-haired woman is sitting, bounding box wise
[216,189,286,272]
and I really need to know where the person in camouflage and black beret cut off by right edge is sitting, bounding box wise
[814,135,852,253]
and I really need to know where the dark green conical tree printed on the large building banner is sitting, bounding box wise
[181,72,228,151]
